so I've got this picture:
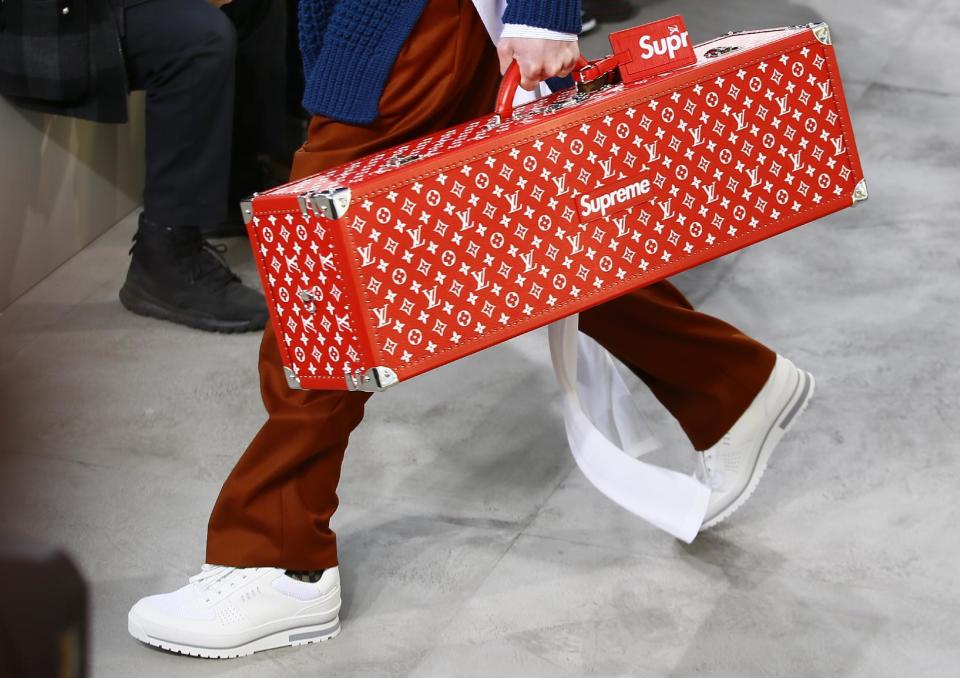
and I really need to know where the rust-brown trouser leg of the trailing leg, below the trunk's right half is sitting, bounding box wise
[580,281,776,450]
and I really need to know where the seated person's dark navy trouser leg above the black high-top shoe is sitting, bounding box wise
[123,0,236,227]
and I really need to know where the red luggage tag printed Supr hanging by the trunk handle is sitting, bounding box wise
[610,15,697,82]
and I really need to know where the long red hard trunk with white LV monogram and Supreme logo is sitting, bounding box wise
[243,24,867,390]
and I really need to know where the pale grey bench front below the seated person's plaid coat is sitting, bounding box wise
[0,94,143,310]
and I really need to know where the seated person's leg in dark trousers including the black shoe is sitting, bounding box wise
[120,0,267,332]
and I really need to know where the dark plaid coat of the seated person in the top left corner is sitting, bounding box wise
[0,0,136,122]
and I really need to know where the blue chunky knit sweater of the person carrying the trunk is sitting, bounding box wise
[299,0,580,124]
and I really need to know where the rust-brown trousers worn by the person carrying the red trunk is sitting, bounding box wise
[207,0,775,570]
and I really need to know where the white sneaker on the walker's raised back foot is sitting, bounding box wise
[697,355,814,531]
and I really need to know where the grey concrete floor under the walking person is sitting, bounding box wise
[0,0,960,678]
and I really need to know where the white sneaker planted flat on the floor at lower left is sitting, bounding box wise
[127,565,340,659]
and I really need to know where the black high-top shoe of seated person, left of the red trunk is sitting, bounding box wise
[120,215,267,332]
